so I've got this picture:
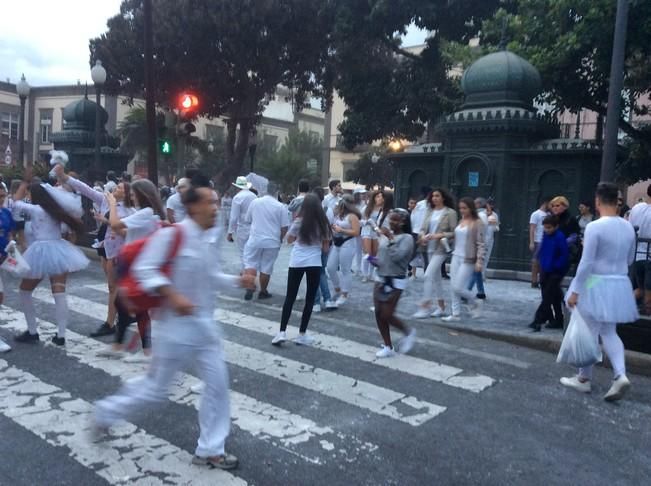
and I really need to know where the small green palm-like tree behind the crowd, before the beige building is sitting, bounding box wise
[256,128,323,194]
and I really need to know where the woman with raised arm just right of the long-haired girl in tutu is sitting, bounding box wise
[54,164,136,337]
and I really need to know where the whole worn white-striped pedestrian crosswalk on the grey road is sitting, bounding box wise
[0,284,496,484]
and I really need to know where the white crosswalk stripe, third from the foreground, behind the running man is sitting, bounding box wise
[34,289,445,426]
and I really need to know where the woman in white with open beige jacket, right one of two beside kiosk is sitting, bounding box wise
[443,197,486,322]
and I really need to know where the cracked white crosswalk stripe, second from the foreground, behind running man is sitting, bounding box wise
[0,304,378,464]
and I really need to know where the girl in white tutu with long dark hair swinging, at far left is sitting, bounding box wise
[14,170,88,346]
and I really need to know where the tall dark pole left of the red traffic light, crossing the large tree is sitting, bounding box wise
[143,0,158,185]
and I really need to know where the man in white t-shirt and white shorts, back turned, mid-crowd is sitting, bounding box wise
[244,182,289,300]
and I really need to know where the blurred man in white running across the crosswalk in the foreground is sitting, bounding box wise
[94,175,253,469]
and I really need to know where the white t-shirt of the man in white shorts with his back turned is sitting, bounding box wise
[245,195,289,249]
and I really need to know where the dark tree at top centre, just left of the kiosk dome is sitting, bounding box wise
[332,0,499,148]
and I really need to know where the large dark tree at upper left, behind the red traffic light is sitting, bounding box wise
[90,0,331,185]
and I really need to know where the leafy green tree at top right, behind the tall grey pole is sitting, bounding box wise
[481,0,651,182]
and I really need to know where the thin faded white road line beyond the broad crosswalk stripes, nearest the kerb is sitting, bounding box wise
[216,292,531,370]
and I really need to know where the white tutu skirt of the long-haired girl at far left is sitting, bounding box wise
[23,239,90,279]
